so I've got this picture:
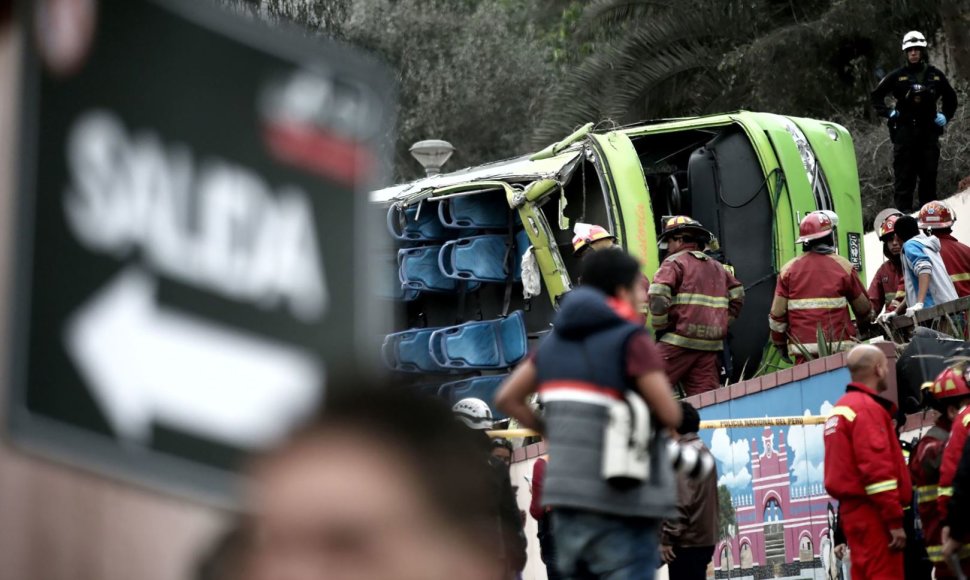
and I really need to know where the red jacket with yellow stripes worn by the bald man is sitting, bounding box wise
[824,383,913,529]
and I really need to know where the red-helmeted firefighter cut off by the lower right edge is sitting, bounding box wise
[927,365,970,576]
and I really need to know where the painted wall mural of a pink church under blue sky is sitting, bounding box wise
[700,369,849,580]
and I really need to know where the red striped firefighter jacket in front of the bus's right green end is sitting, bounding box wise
[768,251,872,355]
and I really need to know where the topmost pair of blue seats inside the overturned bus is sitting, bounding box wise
[387,195,510,242]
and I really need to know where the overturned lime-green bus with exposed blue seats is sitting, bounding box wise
[371,111,865,396]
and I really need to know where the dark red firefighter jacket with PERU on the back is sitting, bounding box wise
[649,250,744,351]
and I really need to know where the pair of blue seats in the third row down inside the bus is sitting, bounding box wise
[381,310,528,373]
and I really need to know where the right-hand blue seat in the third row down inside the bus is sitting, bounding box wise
[428,310,528,370]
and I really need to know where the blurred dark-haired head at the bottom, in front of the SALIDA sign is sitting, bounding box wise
[242,385,505,580]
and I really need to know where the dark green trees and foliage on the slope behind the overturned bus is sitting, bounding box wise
[231,0,970,197]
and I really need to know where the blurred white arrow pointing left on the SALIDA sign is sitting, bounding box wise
[64,268,323,449]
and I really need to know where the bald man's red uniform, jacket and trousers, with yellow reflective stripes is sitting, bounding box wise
[824,383,913,580]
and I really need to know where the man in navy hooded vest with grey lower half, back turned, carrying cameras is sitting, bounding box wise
[496,250,681,580]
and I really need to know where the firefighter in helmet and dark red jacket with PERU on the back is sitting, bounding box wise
[649,216,744,396]
